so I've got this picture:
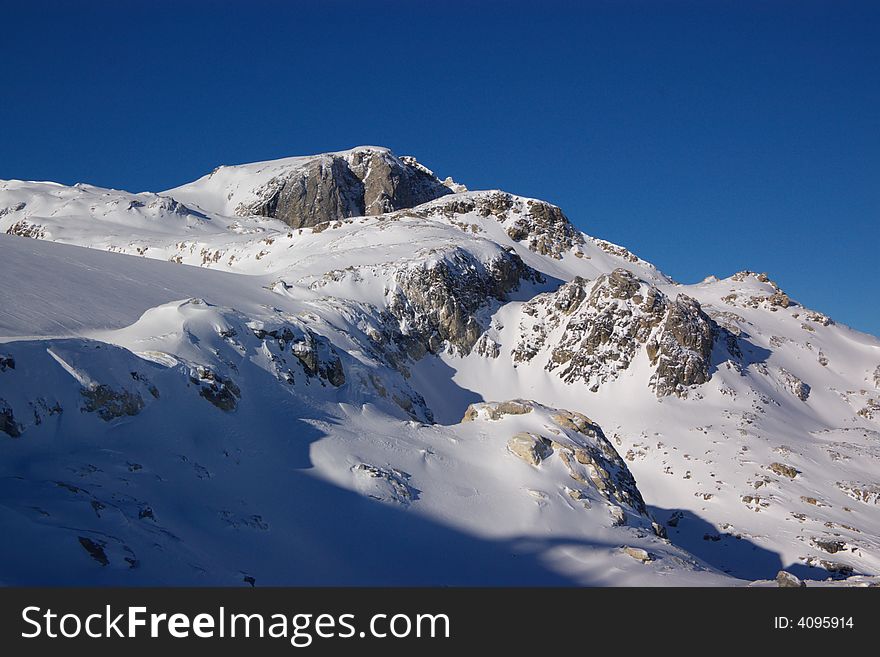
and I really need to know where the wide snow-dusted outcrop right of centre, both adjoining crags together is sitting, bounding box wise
[513,269,724,397]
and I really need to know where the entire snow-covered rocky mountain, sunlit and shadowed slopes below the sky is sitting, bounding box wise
[0,147,880,585]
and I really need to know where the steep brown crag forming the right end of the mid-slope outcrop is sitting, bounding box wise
[647,294,718,397]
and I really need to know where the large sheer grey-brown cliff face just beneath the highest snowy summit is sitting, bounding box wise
[236,148,452,228]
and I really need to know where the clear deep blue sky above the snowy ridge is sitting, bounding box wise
[0,0,880,334]
